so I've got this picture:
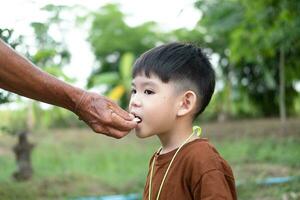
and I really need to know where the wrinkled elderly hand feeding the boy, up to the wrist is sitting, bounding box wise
[74,91,137,138]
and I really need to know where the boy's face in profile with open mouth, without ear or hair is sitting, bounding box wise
[129,75,179,138]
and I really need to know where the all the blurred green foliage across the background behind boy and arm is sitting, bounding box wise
[0,0,300,131]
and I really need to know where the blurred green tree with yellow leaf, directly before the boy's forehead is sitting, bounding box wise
[87,4,171,108]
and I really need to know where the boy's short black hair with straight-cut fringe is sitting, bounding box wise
[132,42,215,117]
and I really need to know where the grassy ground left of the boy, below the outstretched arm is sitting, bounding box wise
[0,130,158,199]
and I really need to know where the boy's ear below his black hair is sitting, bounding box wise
[177,90,197,116]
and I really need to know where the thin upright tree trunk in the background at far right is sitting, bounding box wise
[279,47,286,133]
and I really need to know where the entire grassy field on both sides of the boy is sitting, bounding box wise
[0,119,300,200]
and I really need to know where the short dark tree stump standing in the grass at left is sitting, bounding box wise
[13,131,34,181]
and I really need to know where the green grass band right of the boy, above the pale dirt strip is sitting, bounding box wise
[215,136,300,167]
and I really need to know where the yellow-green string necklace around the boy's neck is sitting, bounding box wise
[148,126,201,200]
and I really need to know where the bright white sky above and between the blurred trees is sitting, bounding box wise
[0,0,201,87]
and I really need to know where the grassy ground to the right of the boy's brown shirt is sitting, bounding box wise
[212,136,300,200]
